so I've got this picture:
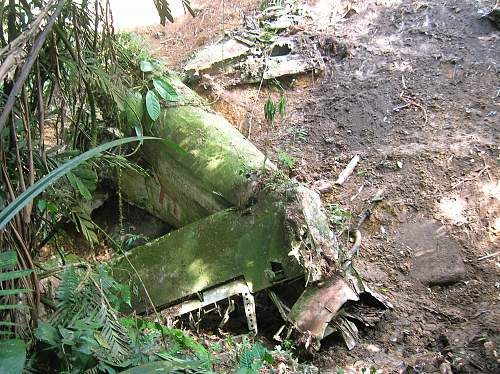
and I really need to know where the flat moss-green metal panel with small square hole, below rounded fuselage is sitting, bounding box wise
[112,194,304,313]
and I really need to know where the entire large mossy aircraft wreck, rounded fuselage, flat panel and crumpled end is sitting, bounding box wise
[112,76,390,347]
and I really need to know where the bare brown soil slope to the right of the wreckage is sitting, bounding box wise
[142,0,500,373]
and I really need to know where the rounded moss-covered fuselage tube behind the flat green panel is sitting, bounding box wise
[122,76,274,227]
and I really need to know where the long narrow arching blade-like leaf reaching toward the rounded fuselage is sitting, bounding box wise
[0,137,158,230]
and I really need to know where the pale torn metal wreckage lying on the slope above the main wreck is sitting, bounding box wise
[184,0,324,84]
